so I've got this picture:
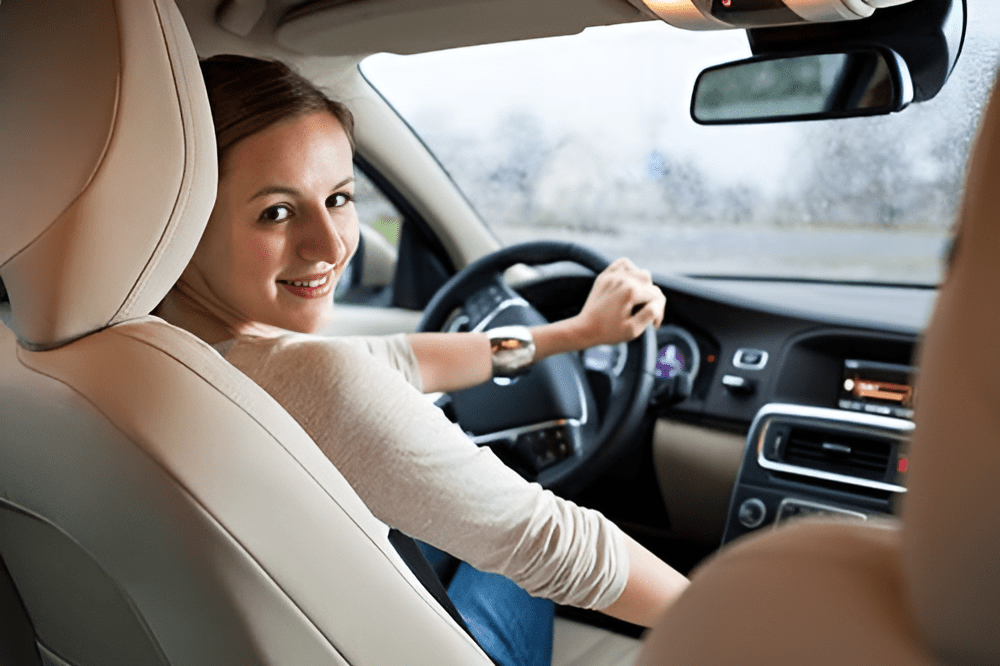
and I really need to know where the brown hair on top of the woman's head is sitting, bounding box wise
[201,55,354,169]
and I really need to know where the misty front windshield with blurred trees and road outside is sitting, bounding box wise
[362,5,1000,284]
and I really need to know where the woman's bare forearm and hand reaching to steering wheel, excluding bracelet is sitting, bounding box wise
[408,259,666,393]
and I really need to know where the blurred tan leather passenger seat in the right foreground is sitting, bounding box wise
[637,75,1000,666]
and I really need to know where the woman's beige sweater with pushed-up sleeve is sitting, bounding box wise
[216,334,628,609]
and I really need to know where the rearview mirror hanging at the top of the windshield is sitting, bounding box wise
[691,48,913,125]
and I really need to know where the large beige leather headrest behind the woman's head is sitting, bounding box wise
[0,0,217,349]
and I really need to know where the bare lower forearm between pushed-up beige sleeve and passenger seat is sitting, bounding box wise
[601,535,688,627]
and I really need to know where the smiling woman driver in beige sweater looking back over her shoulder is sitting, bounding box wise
[157,56,687,663]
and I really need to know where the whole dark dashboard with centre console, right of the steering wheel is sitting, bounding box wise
[522,268,936,547]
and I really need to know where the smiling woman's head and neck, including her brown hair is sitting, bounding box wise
[159,56,358,343]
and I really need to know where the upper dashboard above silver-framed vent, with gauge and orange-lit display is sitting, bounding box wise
[657,278,936,429]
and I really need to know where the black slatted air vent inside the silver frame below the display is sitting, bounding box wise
[781,428,893,481]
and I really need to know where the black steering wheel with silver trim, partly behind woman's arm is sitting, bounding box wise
[418,241,656,493]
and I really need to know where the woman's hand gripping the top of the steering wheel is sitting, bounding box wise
[572,258,667,349]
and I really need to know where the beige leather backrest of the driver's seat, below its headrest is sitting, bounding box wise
[0,316,489,665]
